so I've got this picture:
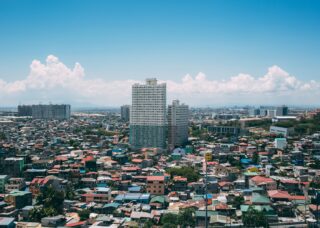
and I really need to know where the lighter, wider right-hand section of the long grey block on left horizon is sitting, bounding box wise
[32,104,71,120]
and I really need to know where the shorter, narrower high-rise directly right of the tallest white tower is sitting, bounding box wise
[168,100,189,149]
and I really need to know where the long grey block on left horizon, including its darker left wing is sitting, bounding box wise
[18,104,71,120]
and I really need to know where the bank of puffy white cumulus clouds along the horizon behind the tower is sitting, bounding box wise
[0,55,320,106]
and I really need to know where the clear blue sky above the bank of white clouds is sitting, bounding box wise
[0,0,320,106]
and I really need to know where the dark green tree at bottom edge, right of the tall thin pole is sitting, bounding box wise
[242,206,268,227]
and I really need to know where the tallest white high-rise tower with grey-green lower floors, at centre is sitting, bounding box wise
[130,78,167,149]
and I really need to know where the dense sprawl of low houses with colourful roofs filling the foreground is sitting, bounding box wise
[0,110,320,228]
